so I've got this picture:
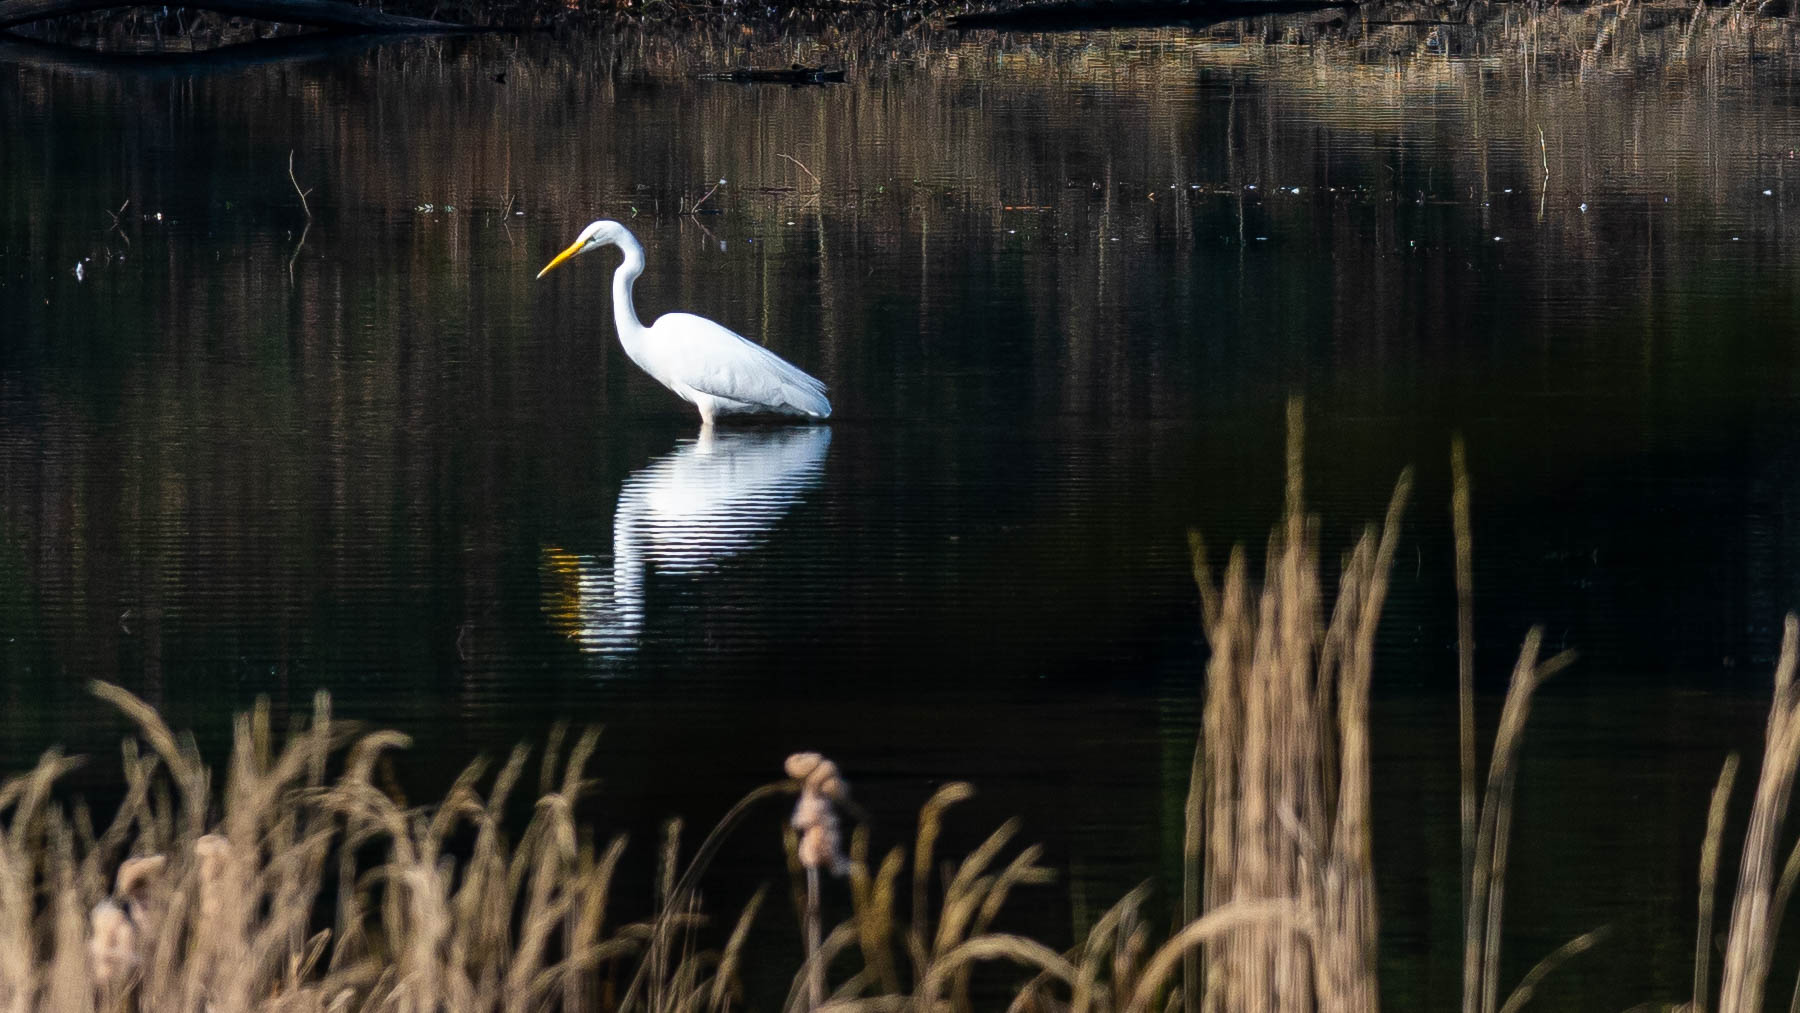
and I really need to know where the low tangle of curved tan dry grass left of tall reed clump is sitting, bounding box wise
[0,684,1287,1013]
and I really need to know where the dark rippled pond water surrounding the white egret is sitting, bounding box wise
[0,7,1800,1008]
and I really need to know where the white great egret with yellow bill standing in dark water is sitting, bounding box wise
[538,221,832,426]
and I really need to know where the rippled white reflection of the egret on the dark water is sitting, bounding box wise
[540,426,832,653]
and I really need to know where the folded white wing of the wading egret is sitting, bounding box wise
[650,313,832,419]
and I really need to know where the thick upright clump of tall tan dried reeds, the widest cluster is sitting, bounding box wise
[1183,399,1411,1011]
